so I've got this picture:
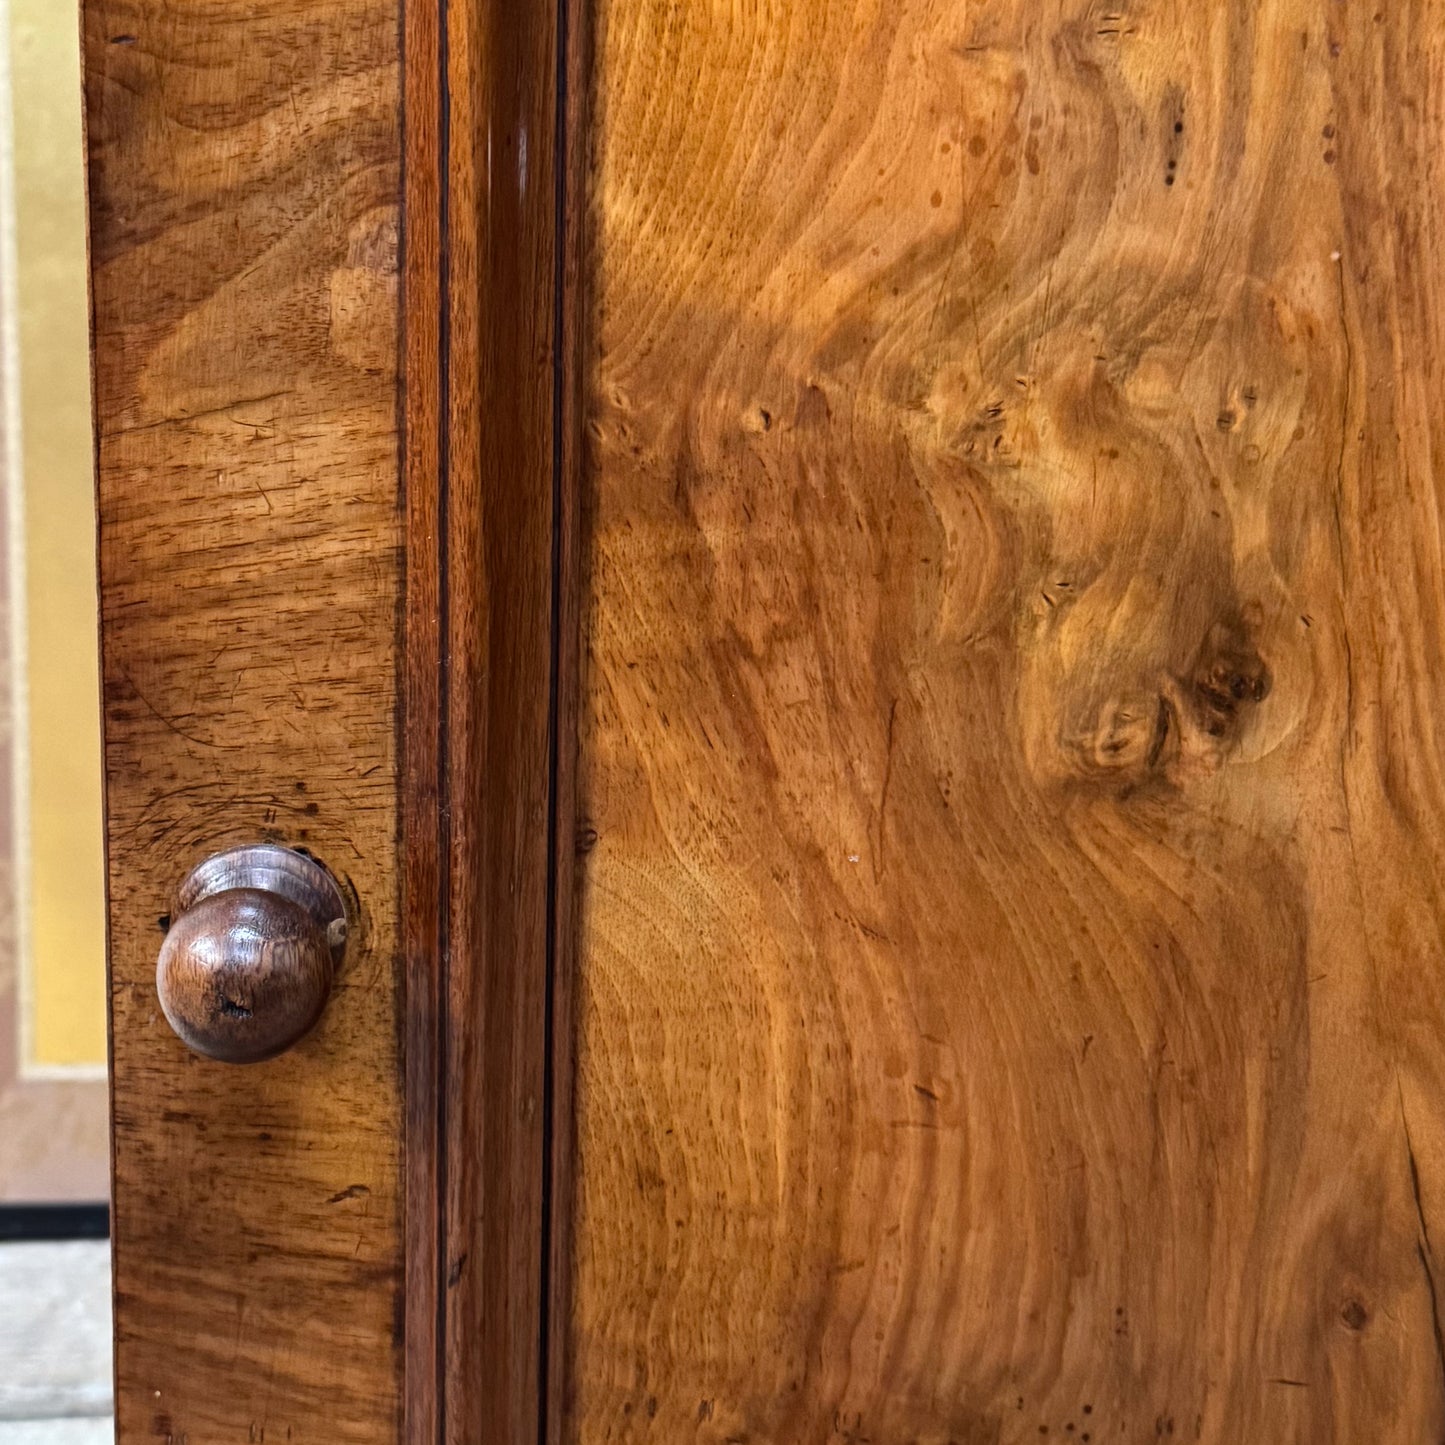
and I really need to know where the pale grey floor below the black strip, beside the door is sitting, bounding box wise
[0,1240,113,1445]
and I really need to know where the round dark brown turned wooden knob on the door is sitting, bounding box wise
[156,844,347,1064]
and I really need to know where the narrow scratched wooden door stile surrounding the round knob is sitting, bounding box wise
[84,0,402,1445]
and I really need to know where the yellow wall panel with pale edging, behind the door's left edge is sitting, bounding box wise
[6,0,105,1072]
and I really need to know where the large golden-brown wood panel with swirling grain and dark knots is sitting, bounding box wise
[568,0,1445,1445]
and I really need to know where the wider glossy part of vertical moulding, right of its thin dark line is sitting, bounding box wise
[444,3,556,1445]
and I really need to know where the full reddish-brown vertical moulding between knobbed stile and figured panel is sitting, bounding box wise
[405,0,561,1445]
